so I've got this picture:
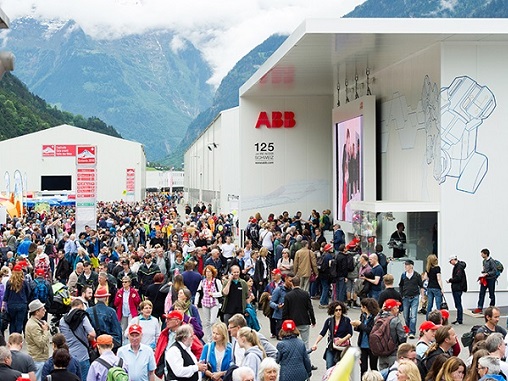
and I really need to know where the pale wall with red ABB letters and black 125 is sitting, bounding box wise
[239,95,333,227]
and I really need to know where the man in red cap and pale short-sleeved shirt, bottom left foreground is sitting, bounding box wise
[117,324,155,381]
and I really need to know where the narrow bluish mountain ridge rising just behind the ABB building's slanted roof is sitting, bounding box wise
[161,35,288,167]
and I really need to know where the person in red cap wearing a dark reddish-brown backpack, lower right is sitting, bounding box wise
[369,299,407,369]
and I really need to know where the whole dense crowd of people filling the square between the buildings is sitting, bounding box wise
[0,194,502,381]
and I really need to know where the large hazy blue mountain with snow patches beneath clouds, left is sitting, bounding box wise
[1,18,213,160]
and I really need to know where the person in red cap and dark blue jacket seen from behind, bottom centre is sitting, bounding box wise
[277,320,312,381]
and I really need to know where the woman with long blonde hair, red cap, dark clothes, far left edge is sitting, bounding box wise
[2,264,30,333]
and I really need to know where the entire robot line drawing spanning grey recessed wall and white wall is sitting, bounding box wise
[381,75,496,193]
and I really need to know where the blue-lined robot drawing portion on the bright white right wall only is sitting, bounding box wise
[434,76,496,193]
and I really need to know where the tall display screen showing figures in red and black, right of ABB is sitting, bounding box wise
[334,116,363,222]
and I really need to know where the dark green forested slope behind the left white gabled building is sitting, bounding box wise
[0,74,121,140]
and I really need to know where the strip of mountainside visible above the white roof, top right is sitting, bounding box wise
[344,0,508,18]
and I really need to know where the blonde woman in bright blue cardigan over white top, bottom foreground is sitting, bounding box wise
[200,322,234,380]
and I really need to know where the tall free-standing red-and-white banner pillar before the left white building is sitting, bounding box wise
[76,145,97,234]
